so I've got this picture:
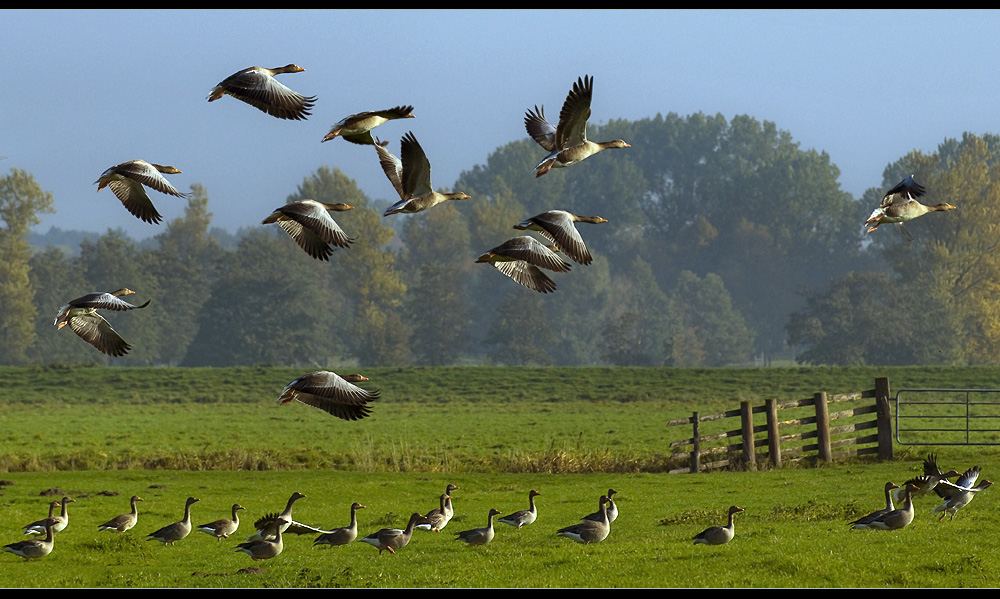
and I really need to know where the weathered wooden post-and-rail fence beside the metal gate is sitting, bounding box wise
[667,378,893,473]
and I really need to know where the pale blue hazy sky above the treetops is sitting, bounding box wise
[0,10,1000,238]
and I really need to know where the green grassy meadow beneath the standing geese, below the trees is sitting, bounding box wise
[0,366,1000,588]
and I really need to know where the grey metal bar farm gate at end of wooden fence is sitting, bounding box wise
[895,389,1000,445]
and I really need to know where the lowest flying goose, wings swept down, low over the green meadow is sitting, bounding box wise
[278,370,380,420]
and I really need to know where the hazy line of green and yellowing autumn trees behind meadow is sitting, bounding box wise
[0,113,1000,368]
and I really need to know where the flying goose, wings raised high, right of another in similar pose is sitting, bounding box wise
[524,75,631,178]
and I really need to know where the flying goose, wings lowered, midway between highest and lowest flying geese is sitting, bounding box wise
[261,200,354,260]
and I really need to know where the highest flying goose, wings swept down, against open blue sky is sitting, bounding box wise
[208,64,316,121]
